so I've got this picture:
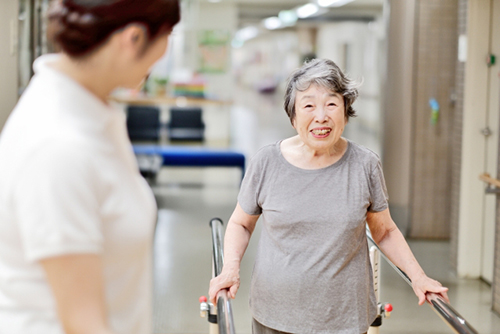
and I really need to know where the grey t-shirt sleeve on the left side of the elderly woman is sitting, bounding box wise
[238,152,263,215]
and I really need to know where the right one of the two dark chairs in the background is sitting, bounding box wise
[167,107,205,141]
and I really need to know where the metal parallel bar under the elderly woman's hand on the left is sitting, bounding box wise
[210,218,236,334]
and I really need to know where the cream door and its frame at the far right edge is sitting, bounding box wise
[457,0,500,283]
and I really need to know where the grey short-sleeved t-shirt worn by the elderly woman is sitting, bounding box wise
[238,141,388,334]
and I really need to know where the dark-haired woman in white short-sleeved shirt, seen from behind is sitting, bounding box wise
[0,0,180,334]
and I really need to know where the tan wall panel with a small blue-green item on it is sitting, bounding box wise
[408,0,458,239]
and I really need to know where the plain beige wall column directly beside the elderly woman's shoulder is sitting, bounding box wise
[383,0,415,233]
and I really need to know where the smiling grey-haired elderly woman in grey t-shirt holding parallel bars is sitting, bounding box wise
[210,60,448,334]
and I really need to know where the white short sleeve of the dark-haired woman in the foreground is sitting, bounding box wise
[13,143,103,262]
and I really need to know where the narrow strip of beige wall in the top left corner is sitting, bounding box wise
[0,0,18,131]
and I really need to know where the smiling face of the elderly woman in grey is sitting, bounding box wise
[292,84,347,153]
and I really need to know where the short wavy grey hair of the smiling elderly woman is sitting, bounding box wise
[284,59,359,123]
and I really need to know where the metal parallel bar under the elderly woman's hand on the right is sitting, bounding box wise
[366,228,478,334]
